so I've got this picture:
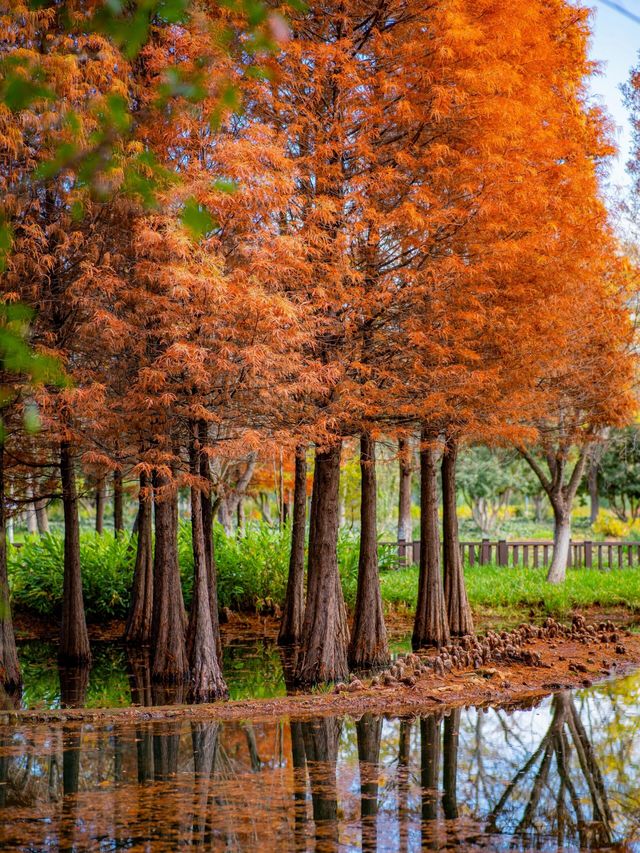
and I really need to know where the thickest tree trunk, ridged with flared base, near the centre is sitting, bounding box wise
[296,444,349,684]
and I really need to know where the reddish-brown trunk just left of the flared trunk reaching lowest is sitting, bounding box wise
[151,475,189,684]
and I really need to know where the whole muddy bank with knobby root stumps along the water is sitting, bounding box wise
[0,617,640,725]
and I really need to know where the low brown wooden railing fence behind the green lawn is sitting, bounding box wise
[380,539,640,569]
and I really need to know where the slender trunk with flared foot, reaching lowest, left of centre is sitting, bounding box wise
[187,425,229,702]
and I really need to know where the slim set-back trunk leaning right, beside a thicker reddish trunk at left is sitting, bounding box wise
[124,473,153,646]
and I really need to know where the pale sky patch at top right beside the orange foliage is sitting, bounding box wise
[586,0,640,196]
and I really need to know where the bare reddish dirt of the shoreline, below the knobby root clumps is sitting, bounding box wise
[0,623,640,726]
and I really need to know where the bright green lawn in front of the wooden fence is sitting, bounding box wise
[382,565,640,618]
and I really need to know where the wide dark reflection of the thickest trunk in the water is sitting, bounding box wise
[301,717,341,851]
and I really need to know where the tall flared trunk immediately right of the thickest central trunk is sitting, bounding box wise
[348,433,389,669]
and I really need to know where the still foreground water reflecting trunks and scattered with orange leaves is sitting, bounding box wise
[0,675,640,851]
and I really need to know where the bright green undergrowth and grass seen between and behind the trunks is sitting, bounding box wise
[8,524,640,621]
